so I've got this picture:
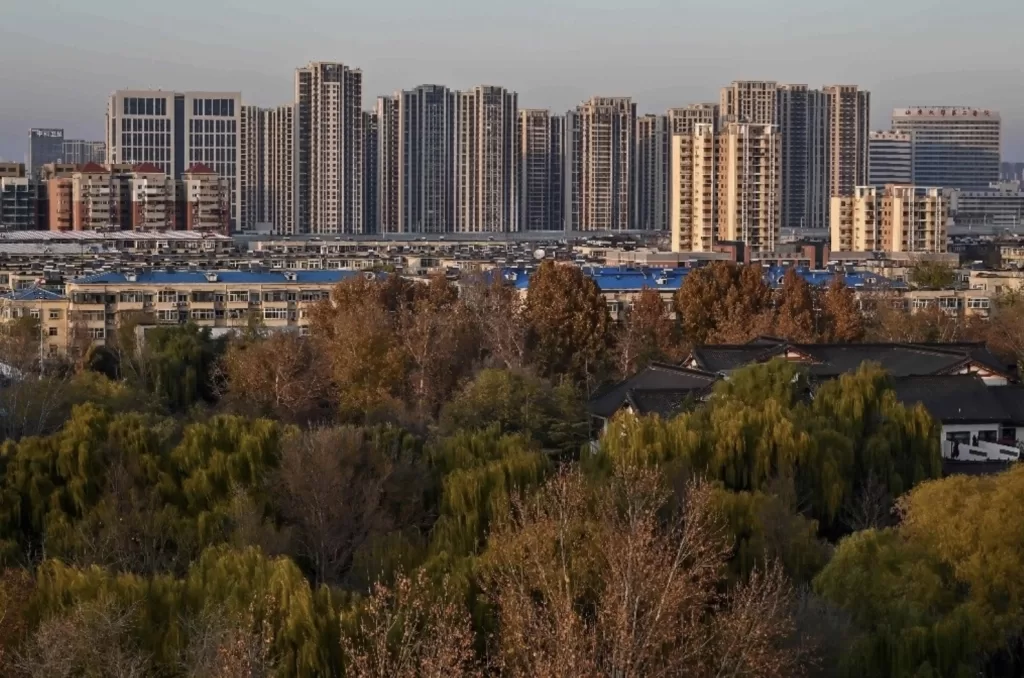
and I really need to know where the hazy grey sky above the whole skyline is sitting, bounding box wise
[0,0,1024,161]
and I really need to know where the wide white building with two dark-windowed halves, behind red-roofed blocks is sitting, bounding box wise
[106,90,242,228]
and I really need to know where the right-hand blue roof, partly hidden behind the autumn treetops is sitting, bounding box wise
[502,266,906,292]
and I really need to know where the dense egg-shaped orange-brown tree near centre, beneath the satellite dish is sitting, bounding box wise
[523,261,611,386]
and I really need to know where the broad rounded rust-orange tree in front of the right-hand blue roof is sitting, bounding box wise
[675,262,774,346]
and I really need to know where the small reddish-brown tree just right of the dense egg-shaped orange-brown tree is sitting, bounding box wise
[614,288,678,377]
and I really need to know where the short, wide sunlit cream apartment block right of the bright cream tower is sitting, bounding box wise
[831,184,948,252]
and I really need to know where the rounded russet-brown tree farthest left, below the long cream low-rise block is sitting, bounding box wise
[217,332,331,423]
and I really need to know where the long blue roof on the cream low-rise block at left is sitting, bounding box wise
[74,270,387,285]
